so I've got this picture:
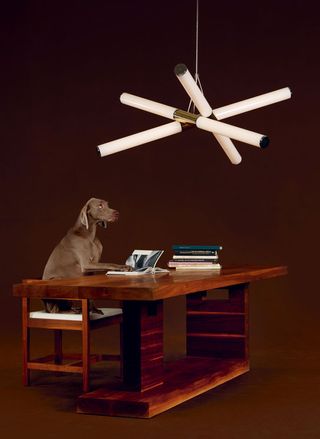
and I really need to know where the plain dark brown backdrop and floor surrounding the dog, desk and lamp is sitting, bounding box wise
[0,0,320,438]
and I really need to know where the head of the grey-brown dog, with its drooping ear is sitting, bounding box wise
[80,198,119,229]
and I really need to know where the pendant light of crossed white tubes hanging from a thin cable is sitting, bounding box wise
[97,0,291,164]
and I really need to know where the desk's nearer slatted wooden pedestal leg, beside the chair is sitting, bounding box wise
[122,300,163,392]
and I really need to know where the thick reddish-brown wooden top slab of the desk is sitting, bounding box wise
[13,266,287,300]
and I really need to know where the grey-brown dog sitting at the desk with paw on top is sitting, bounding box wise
[42,198,131,314]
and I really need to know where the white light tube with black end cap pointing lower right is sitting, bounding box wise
[196,116,269,148]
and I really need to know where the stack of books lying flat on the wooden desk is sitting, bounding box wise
[168,245,222,270]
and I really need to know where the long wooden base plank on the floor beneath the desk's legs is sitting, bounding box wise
[77,357,249,418]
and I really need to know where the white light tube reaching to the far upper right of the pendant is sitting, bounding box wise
[212,87,291,120]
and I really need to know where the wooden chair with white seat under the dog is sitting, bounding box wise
[22,280,122,392]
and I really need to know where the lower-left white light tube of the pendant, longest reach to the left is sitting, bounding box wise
[97,122,182,157]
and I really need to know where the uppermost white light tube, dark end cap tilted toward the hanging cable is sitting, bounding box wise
[174,64,212,117]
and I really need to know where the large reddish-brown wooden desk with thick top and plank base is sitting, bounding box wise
[13,266,287,418]
